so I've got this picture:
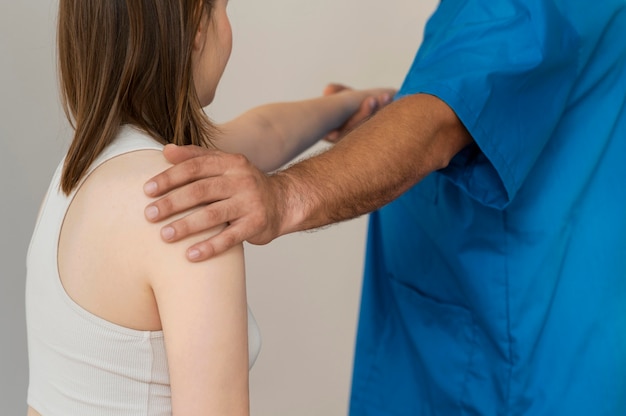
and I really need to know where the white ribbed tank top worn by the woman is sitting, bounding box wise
[26,127,261,416]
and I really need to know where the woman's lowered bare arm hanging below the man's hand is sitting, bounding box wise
[144,154,249,416]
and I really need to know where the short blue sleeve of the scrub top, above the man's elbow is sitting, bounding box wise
[398,0,579,209]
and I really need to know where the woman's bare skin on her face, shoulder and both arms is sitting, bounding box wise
[28,0,395,416]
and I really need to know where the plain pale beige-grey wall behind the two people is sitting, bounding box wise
[0,0,437,416]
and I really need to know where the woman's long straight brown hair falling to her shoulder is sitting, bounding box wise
[57,0,215,194]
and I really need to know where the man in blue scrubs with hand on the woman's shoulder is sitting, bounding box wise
[146,0,626,416]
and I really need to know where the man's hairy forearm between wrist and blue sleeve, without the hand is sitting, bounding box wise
[272,94,472,235]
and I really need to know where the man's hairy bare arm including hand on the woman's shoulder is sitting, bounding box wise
[146,94,472,261]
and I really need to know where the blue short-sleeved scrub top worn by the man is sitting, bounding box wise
[350,0,626,416]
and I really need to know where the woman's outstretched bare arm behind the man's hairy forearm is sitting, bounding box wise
[216,88,395,172]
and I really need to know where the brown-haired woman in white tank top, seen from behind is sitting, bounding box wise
[26,0,392,416]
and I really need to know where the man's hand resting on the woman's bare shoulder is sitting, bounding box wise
[144,145,285,261]
